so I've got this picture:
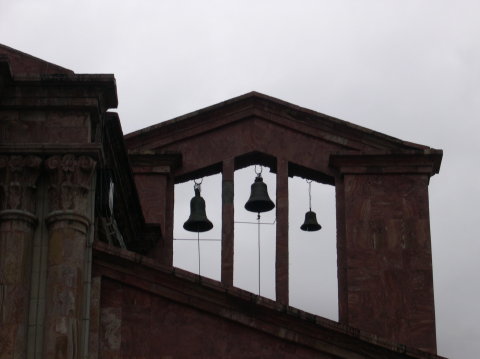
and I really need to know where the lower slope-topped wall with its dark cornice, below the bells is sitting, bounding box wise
[94,243,446,359]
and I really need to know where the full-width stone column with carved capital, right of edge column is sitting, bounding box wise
[43,154,95,358]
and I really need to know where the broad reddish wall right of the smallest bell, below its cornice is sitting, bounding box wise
[339,174,436,352]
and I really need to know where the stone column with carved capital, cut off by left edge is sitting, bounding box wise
[0,156,41,359]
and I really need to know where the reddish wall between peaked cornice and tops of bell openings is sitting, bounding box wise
[143,118,347,180]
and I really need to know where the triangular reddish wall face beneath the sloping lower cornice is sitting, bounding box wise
[99,278,332,359]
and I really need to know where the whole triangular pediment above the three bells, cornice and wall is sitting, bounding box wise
[125,92,436,184]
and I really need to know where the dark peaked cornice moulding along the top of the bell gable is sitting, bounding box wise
[125,92,428,152]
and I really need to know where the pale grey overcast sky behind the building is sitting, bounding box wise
[0,0,480,358]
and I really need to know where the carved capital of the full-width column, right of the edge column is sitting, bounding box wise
[45,154,96,215]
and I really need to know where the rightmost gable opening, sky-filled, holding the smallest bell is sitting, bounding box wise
[288,177,338,320]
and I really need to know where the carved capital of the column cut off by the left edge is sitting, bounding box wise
[0,156,42,213]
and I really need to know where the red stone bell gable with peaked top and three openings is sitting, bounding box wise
[125,92,442,352]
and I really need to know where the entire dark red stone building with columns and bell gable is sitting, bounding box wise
[0,45,442,359]
